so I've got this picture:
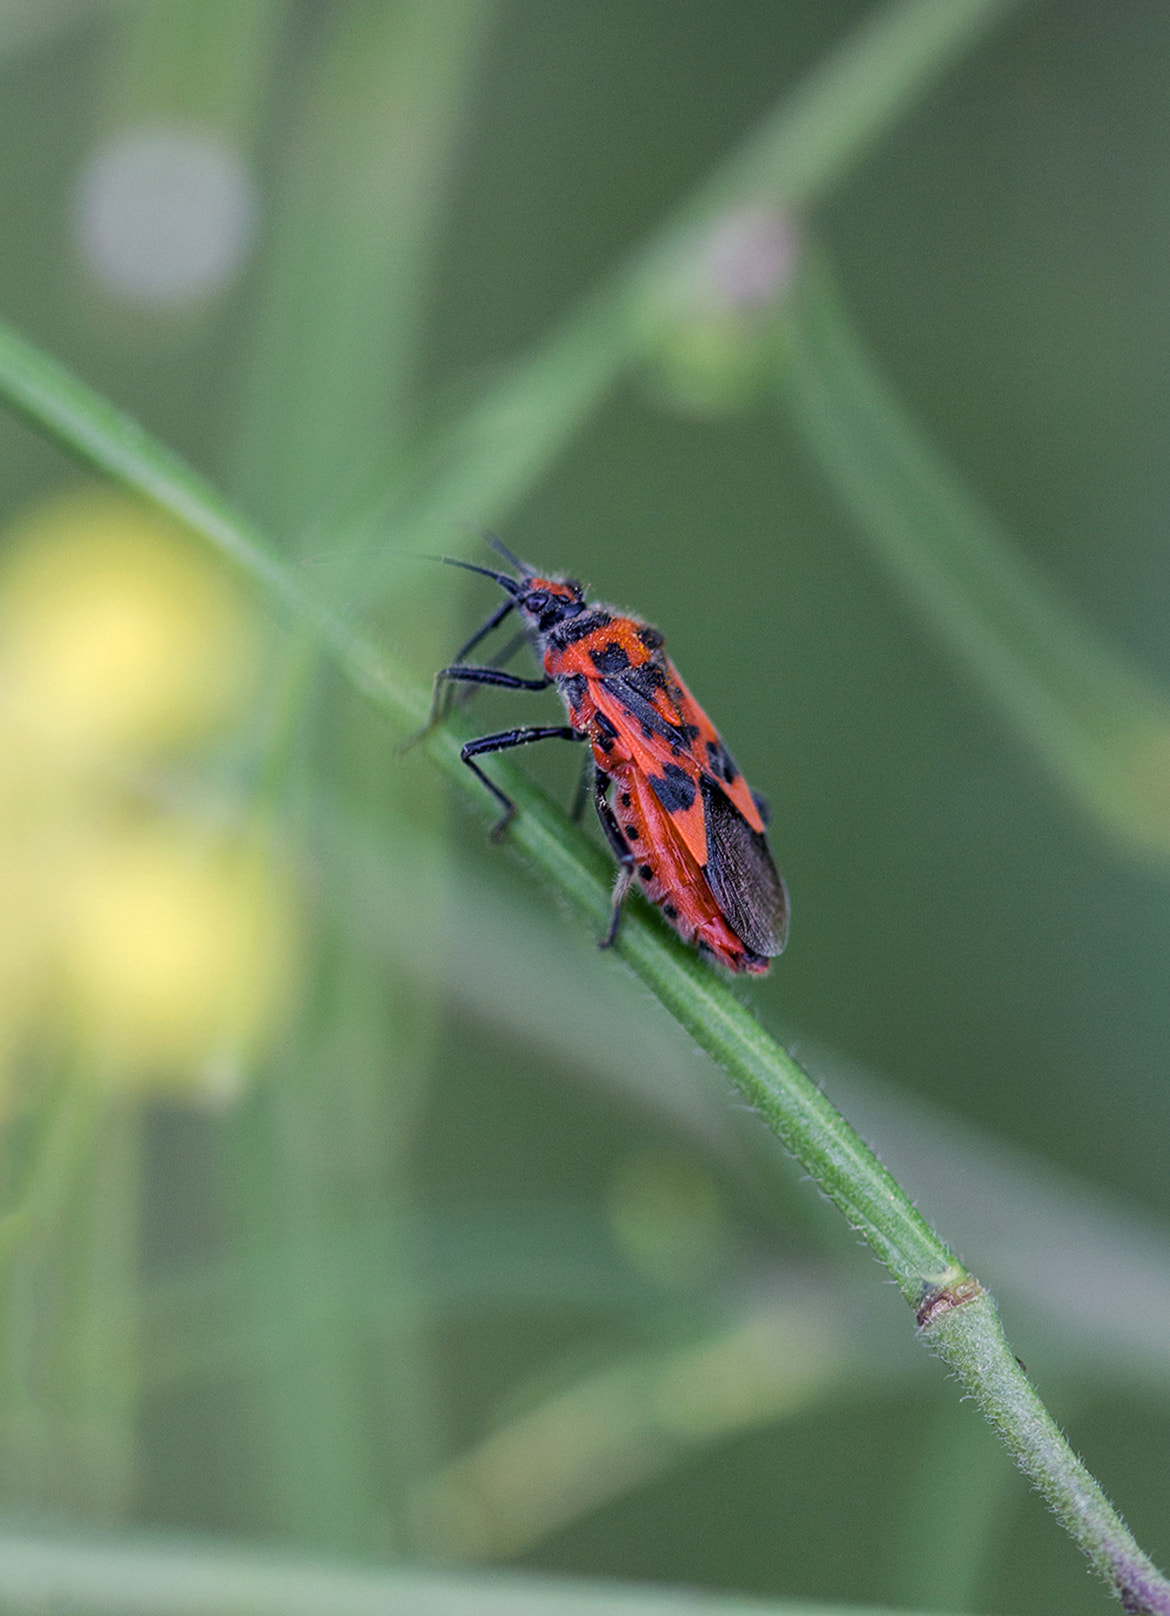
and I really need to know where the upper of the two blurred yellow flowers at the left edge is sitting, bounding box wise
[0,490,255,755]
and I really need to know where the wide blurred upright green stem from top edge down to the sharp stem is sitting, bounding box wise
[229,0,495,536]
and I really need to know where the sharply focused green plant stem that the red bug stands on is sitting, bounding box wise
[0,328,1170,1616]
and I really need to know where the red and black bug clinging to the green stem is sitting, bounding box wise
[431,538,789,974]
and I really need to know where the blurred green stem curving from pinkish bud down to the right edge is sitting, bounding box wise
[782,263,1170,869]
